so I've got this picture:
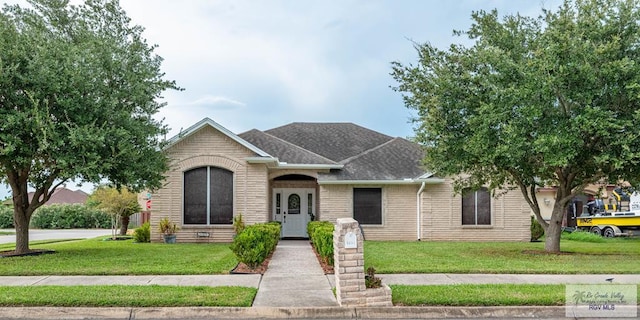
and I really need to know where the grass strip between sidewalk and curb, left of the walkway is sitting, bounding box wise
[0,285,258,307]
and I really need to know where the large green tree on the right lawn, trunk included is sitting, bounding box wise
[392,0,640,252]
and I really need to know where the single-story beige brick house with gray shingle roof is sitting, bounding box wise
[151,118,530,242]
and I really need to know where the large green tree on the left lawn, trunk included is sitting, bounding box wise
[0,0,178,253]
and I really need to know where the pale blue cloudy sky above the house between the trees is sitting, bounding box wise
[0,0,560,199]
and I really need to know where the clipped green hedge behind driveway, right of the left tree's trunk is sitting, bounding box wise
[31,204,111,229]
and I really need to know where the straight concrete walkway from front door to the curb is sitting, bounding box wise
[253,240,338,307]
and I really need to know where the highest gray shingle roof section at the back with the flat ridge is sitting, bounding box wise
[265,122,393,162]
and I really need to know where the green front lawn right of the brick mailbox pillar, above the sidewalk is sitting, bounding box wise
[364,238,640,274]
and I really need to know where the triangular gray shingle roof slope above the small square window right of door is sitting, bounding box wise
[318,138,425,181]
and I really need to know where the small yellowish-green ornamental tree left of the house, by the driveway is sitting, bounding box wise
[87,186,142,238]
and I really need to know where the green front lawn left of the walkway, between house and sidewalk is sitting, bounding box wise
[0,238,237,276]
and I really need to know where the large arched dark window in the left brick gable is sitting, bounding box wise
[184,167,233,225]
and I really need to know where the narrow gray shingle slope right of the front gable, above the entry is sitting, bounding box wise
[238,129,336,164]
